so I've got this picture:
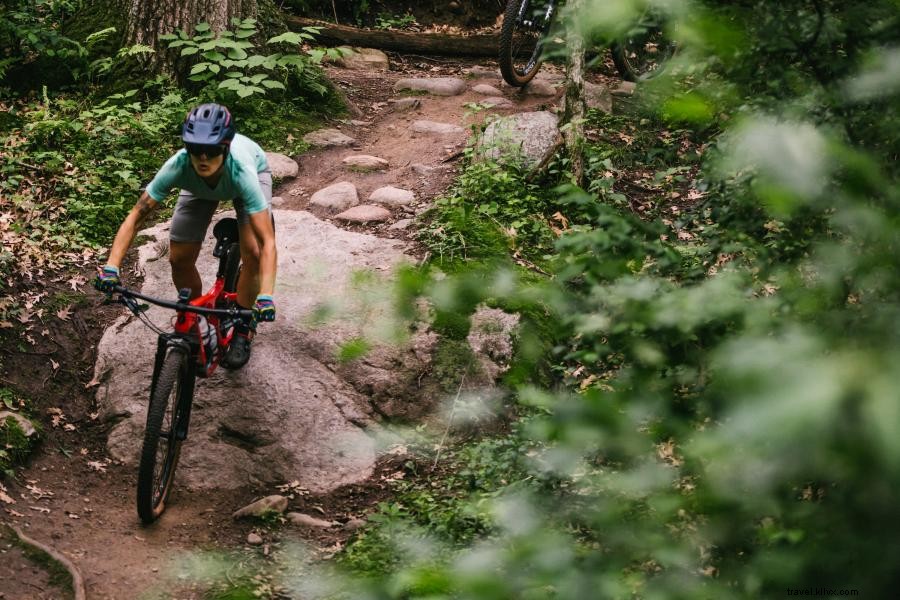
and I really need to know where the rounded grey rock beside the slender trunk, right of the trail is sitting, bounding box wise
[476,111,560,168]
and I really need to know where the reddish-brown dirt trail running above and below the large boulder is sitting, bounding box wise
[0,54,596,600]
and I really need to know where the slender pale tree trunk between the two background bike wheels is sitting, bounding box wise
[563,0,587,187]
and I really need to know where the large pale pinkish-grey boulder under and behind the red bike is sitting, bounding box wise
[95,210,508,492]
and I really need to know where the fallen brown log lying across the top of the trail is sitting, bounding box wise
[286,16,500,58]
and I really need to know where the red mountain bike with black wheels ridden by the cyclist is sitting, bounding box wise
[114,218,253,524]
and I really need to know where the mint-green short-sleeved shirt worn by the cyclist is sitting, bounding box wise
[147,134,269,214]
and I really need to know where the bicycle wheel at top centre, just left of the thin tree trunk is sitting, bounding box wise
[498,0,554,87]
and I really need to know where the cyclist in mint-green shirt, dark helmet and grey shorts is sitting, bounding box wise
[94,104,277,369]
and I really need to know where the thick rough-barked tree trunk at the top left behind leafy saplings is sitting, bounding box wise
[119,0,259,69]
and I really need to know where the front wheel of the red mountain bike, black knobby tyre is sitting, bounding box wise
[137,348,191,525]
